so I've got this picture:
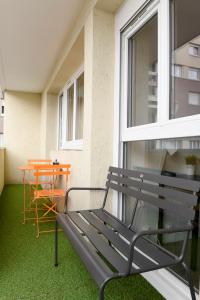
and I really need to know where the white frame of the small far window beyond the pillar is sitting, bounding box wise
[58,65,84,150]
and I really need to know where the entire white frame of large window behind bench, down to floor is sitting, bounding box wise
[112,0,200,300]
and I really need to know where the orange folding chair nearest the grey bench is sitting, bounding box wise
[33,164,71,238]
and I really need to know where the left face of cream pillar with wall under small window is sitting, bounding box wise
[51,14,93,210]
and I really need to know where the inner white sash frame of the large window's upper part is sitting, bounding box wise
[118,0,200,142]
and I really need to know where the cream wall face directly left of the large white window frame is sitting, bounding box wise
[91,9,115,211]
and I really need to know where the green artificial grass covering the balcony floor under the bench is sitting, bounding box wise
[0,185,163,300]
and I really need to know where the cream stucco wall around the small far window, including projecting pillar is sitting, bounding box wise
[41,9,114,209]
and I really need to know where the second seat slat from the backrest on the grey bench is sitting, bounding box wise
[80,211,157,269]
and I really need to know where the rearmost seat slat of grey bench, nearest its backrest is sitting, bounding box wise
[92,209,177,264]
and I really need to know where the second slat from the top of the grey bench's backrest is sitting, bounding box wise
[107,174,197,207]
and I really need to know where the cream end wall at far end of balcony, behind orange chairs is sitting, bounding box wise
[4,91,41,183]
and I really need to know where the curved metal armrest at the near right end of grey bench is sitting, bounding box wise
[127,224,193,274]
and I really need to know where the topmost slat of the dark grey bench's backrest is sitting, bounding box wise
[109,167,200,192]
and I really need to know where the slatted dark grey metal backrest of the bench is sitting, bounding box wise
[106,167,200,220]
